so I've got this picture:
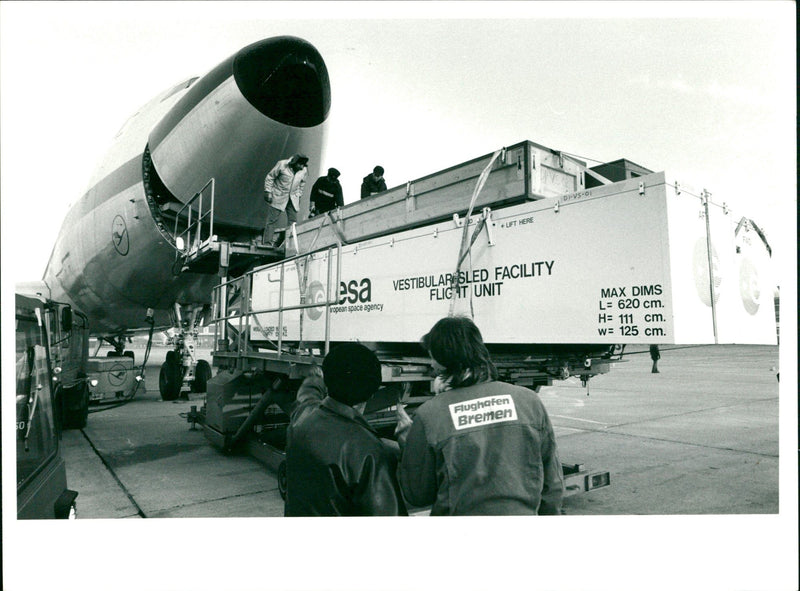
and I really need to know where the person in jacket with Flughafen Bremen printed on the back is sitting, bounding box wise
[397,317,564,515]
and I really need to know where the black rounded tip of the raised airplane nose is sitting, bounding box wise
[233,37,331,127]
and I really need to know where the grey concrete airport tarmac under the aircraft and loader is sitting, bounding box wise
[62,345,779,519]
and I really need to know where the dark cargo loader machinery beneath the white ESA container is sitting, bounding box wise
[202,350,610,500]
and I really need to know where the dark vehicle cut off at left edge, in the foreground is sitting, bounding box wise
[16,294,78,519]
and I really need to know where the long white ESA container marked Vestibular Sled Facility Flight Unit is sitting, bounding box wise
[249,172,776,345]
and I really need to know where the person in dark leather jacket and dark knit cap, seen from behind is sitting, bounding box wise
[285,343,407,517]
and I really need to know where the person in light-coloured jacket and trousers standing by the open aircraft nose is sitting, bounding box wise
[264,154,308,247]
